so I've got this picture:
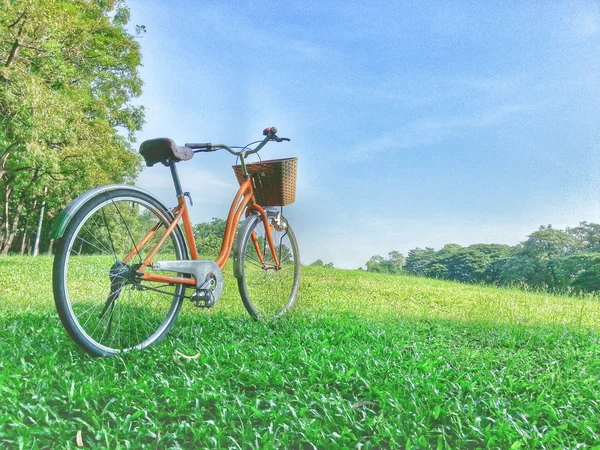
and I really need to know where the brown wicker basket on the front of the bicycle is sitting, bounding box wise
[232,158,298,206]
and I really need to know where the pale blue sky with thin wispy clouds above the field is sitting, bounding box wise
[128,0,600,269]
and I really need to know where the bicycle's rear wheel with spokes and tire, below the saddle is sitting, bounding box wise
[53,189,187,356]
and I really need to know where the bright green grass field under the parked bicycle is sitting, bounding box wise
[0,257,600,449]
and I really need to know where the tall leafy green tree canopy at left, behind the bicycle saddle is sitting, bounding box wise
[0,0,143,253]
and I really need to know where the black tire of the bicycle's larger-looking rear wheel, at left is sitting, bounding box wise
[52,189,189,357]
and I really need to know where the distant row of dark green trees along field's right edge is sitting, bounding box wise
[366,222,600,292]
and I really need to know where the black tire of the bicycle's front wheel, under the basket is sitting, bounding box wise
[237,212,301,320]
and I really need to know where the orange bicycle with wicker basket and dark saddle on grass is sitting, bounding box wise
[51,127,300,356]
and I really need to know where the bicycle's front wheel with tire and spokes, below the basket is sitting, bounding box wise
[236,212,300,320]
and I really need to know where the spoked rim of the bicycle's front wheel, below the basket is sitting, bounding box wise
[243,218,300,320]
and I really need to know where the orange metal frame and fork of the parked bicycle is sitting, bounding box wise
[123,177,279,286]
